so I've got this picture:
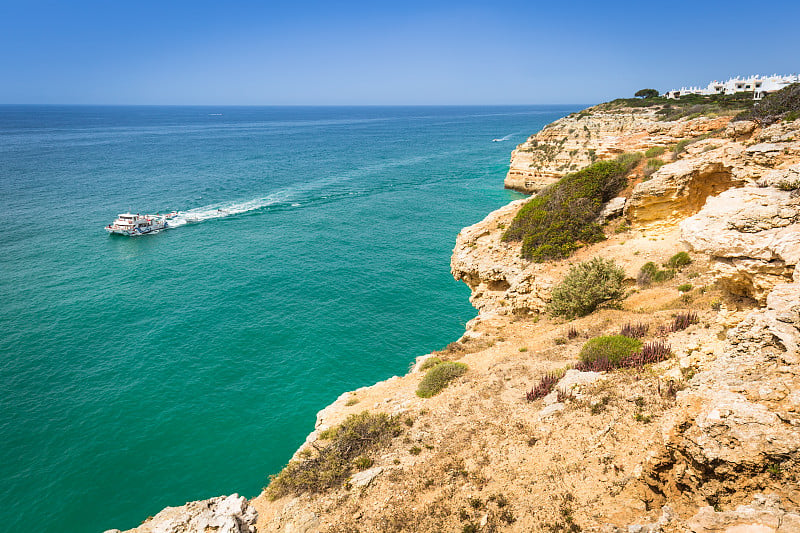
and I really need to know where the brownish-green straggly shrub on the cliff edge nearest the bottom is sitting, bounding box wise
[267,411,402,500]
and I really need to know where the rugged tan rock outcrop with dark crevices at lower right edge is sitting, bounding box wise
[647,283,800,508]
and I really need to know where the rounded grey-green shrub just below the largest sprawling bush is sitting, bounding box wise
[548,257,625,318]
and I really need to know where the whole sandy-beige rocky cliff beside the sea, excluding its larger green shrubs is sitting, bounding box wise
[115,104,800,533]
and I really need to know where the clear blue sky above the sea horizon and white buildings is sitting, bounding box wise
[0,0,800,105]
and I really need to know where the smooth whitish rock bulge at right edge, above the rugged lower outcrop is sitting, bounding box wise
[681,185,800,303]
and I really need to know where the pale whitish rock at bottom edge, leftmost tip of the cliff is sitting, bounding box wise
[117,494,257,533]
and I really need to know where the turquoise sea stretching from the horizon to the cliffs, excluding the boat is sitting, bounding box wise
[0,106,579,532]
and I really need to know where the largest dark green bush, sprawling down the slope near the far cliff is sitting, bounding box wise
[503,154,641,262]
